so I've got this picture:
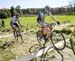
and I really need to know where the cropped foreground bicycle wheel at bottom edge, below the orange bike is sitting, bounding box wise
[44,48,64,61]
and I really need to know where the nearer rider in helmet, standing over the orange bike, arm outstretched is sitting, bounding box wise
[37,6,60,40]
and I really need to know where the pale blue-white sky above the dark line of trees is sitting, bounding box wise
[0,0,71,9]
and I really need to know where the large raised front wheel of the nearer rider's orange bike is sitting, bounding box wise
[51,31,66,50]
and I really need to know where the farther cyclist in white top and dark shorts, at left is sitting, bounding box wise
[10,13,21,36]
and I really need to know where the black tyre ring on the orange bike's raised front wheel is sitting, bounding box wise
[51,31,66,50]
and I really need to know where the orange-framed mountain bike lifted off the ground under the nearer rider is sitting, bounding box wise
[36,24,66,50]
